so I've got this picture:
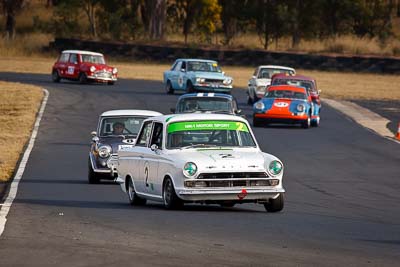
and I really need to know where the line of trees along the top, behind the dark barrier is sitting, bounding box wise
[0,0,400,49]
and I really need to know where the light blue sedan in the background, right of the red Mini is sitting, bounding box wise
[164,59,233,94]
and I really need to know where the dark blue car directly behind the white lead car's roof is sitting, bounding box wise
[171,93,242,115]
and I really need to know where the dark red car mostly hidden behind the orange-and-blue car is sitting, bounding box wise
[271,73,321,107]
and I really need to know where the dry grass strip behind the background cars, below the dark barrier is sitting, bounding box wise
[0,57,400,100]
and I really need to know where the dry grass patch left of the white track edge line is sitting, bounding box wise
[0,81,43,181]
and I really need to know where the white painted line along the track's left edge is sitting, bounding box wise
[0,88,49,236]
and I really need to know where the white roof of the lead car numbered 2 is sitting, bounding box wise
[148,113,247,123]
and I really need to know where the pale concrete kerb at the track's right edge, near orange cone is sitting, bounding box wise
[323,99,400,144]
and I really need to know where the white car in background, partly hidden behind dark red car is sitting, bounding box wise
[247,65,296,105]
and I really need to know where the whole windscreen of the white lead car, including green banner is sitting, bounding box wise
[166,120,256,149]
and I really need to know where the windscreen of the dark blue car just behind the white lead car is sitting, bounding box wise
[177,97,232,113]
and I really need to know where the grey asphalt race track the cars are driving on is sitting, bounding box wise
[0,73,400,266]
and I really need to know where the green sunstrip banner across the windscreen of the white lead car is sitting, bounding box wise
[168,121,249,133]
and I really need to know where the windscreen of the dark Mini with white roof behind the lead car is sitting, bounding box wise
[100,116,147,137]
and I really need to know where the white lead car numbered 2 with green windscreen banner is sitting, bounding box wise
[116,114,285,212]
